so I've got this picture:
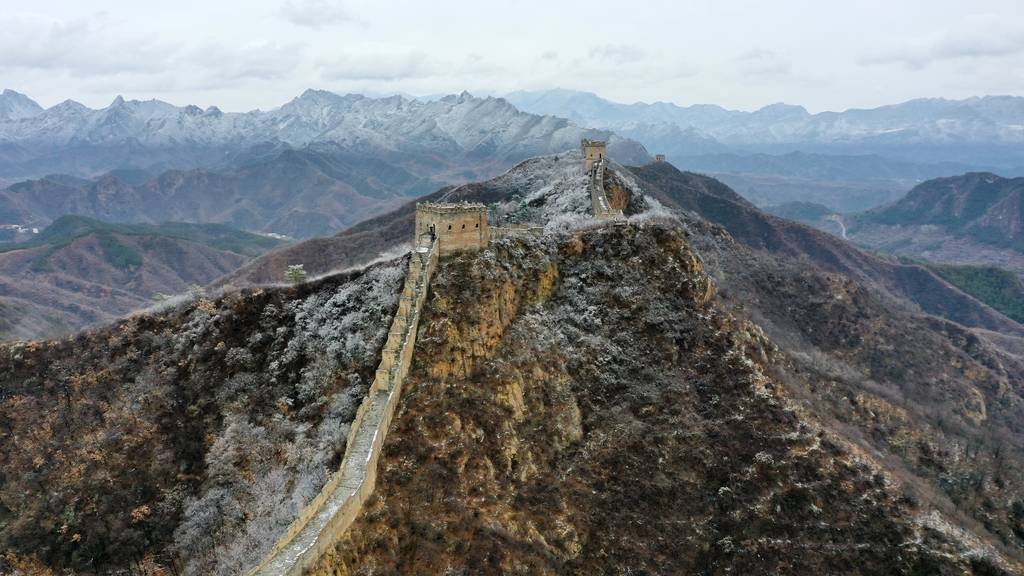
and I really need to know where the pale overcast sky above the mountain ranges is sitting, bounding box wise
[0,0,1024,112]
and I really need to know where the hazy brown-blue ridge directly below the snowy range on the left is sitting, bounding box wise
[0,142,440,238]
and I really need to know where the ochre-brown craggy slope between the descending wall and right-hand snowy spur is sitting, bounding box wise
[313,224,1015,575]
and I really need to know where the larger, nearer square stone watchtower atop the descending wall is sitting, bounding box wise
[416,202,489,256]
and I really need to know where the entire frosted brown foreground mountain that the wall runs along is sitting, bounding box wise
[0,154,1024,575]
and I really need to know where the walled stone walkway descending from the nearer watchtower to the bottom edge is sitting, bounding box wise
[249,237,440,576]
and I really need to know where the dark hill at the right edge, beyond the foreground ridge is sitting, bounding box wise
[847,172,1024,274]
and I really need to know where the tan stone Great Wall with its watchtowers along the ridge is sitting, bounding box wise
[249,140,623,576]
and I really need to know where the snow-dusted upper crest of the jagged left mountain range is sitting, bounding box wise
[0,90,644,162]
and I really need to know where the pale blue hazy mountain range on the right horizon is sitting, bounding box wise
[506,89,1024,168]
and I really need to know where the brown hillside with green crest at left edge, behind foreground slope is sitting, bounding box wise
[0,216,282,338]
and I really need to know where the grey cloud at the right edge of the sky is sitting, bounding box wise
[858,16,1024,70]
